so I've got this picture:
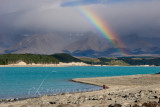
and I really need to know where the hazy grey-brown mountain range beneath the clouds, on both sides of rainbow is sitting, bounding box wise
[0,32,160,57]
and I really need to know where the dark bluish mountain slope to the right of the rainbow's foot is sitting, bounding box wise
[122,34,160,55]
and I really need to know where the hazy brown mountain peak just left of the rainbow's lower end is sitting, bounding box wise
[64,33,112,53]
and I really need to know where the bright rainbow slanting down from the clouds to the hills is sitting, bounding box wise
[77,7,127,56]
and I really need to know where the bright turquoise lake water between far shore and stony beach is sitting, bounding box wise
[0,67,160,99]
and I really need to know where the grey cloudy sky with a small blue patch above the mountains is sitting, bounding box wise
[0,0,160,42]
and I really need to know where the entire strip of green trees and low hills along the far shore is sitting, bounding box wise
[0,53,160,66]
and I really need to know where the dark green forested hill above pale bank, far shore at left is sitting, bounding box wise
[0,53,83,65]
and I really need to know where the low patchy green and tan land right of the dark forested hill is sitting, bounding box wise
[80,57,160,66]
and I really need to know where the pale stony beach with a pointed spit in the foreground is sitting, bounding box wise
[0,74,160,107]
